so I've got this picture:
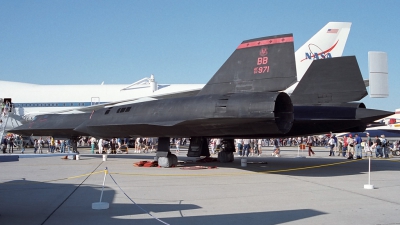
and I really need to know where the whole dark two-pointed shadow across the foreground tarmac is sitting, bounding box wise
[0,180,325,225]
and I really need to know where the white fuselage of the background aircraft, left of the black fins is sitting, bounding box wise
[0,75,204,130]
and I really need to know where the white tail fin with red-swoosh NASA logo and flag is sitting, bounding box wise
[296,22,351,81]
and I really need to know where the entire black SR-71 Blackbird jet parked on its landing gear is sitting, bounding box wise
[11,34,393,166]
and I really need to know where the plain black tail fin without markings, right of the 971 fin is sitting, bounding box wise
[290,56,368,104]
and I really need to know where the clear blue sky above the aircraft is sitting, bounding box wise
[0,0,400,111]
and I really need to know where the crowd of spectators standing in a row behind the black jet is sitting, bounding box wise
[1,134,400,159]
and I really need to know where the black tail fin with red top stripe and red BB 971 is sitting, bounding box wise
[198,34,297,95]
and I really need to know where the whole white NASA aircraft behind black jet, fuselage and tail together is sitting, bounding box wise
[0,22,351,132]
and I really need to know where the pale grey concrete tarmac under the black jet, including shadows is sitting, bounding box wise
[0,147,400,225]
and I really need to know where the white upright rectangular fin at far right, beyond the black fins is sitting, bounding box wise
[368,52,389,98]
